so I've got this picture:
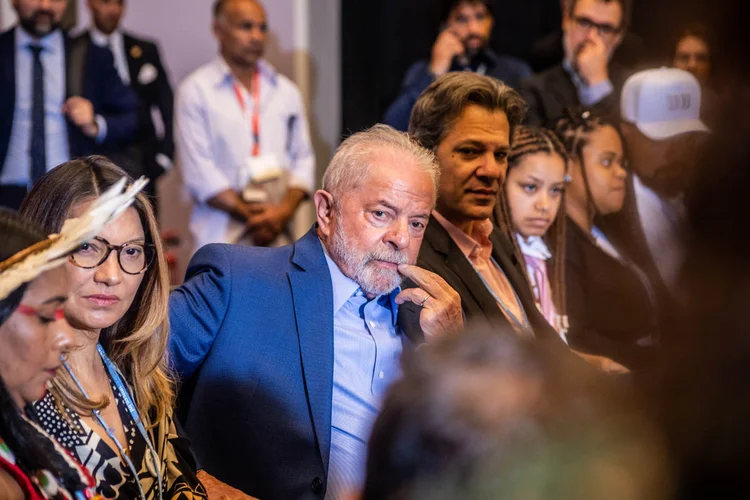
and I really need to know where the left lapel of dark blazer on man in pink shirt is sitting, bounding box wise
[425,217,507,326]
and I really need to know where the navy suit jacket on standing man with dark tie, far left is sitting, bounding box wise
[0,28,138,182]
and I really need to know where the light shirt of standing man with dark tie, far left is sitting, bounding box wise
[0,28,70,186]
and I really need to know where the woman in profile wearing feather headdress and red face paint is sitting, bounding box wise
[0,182,143,500]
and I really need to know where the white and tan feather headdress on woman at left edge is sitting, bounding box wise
[0,177,148,300]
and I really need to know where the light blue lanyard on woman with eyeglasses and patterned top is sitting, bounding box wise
[63,344,163,500]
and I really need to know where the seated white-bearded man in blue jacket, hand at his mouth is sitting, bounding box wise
[170,125,463,499]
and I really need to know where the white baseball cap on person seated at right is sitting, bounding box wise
[620,68,710,141]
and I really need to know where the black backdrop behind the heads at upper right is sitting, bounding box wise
[342,0,750,136]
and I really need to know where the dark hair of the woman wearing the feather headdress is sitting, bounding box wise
[0,209,86,492]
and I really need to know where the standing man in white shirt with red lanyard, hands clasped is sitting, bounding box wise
[175,0,315,249]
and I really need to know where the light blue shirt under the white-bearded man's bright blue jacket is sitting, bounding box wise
[326,254,403,500]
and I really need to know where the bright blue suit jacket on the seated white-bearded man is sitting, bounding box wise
[170,229,333,499]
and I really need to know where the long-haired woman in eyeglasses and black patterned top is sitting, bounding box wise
[21,157,206,499]
